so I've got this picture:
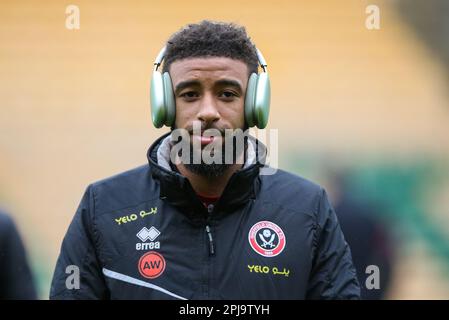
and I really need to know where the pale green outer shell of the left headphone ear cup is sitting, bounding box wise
[150,71,165,128]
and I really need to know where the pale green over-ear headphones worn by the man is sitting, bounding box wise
[150,47,271,129]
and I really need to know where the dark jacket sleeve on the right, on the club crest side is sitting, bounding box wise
[306,190,360,299]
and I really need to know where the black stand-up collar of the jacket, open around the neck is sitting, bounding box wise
[147,132,266,219]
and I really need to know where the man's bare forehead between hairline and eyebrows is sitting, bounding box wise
[169,57,248,87]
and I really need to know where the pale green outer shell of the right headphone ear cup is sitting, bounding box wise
[254,72,271,129]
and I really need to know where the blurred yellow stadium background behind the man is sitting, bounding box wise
[0,0,449,299]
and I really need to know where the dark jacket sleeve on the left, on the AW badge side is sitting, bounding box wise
[50,186,108,299]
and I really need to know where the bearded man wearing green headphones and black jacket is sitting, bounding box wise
[50,21,360,299]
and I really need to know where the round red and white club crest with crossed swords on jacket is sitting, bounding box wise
[248,221,285,257]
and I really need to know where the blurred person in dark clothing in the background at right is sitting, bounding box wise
[327,170,396,300]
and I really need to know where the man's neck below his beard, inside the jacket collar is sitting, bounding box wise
[176,164,243,197]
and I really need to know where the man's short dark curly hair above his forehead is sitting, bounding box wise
[162,20,258,74]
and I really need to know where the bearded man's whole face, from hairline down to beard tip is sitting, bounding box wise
[170,57,248,177]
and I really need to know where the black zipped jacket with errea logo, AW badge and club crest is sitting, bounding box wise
[50,135,360,299]
